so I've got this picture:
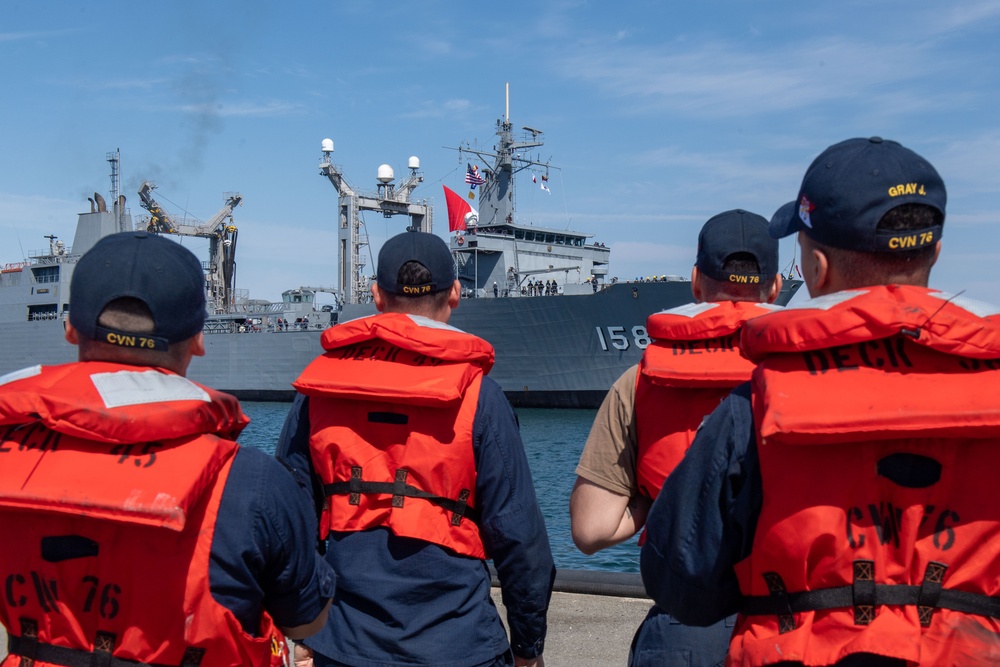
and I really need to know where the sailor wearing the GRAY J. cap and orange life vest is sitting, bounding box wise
[641,137,1000,665]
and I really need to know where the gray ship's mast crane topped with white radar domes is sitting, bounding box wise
[319,139,432,304]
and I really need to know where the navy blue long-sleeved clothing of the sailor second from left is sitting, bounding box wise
[275,384,555,667]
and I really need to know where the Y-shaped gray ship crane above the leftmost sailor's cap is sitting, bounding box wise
[139,181,243,314]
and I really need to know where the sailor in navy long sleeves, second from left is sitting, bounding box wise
[276,232,555,667]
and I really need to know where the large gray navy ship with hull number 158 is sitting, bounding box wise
[0,113,802,408]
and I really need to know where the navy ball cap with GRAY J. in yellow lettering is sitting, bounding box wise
[770,137,948,252]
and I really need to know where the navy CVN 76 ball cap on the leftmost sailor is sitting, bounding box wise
[69,232,206,350]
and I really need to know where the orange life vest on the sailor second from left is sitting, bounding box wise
[294,313,493,558]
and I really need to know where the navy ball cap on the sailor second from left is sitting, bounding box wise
[378,232,455,296]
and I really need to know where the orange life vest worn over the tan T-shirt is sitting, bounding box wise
[635,301,778,498]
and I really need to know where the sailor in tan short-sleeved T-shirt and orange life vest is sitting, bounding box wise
[570,209,782,665]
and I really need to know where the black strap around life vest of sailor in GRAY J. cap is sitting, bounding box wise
[741,561,1000,633]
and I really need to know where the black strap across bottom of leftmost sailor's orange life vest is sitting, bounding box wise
[7,618,205,667]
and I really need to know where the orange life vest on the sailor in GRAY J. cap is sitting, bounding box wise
[730,286,1000,665]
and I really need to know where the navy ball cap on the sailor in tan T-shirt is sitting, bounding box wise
[695,208,778,283]
